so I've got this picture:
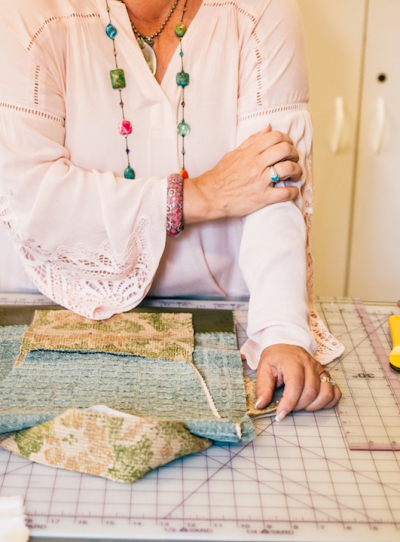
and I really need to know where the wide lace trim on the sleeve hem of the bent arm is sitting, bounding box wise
[0,195,155,320]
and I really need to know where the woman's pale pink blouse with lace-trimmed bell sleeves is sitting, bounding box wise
[0,0,343,367]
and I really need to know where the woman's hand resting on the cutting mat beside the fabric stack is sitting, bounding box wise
[256,344,342,421]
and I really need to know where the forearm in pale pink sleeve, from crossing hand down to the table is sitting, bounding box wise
[239,202,316,366]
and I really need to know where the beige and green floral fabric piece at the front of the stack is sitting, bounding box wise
[1,407,212,483]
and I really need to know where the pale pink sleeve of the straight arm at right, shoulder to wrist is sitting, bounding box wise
[237,0,317,368]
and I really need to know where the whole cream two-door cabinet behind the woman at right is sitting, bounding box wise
[298,0,400,301]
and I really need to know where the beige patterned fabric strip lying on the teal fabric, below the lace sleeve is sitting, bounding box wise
[15,310,194,366]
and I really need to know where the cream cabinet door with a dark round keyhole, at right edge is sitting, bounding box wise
[348,0,400,301]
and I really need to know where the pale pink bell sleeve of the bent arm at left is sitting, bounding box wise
[0,21,167,319]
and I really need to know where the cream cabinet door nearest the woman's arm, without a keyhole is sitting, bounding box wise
[299,0,366,296]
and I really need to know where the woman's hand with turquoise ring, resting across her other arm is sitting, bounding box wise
[183,125,303,224]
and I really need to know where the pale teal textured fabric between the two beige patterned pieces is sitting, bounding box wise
[0,347,255,443]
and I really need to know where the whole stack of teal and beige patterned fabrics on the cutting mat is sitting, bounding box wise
[0,308,277,483]
